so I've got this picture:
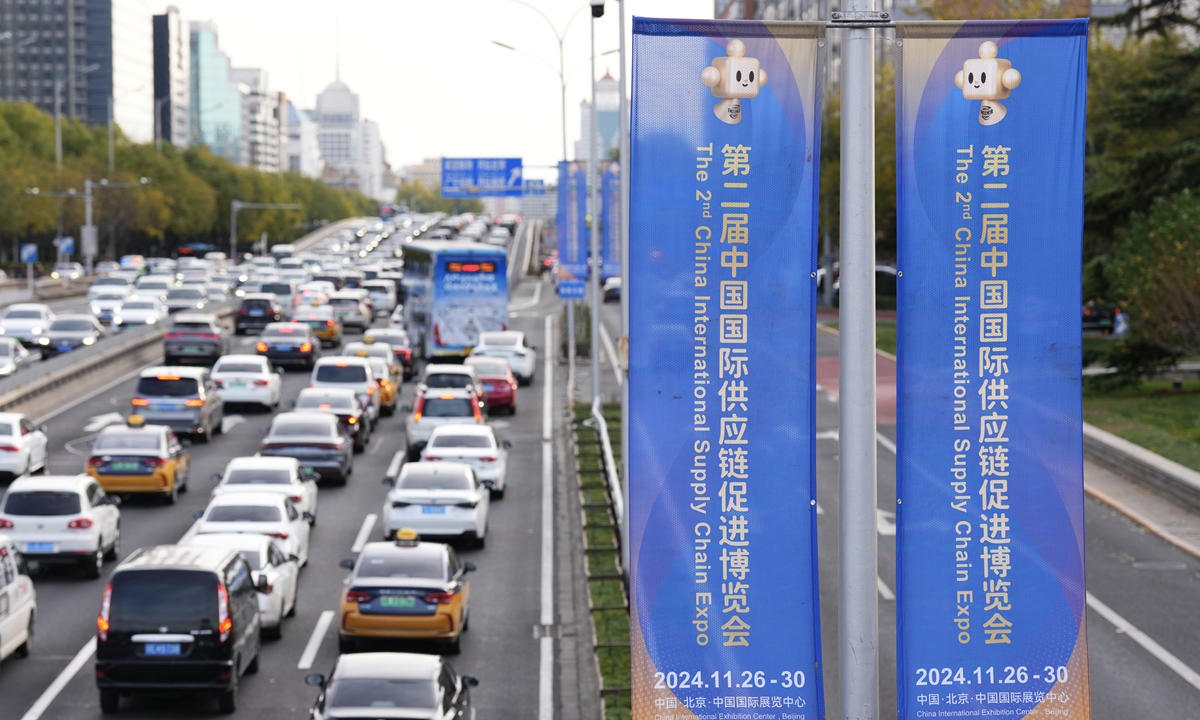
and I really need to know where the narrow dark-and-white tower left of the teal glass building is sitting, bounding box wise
[154,6,192,148]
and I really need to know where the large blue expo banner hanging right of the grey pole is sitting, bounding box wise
[896,20,1091,720]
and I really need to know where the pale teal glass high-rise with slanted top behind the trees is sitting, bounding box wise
[188,22,242,166]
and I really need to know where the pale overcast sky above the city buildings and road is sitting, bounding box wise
[150,0,713,179]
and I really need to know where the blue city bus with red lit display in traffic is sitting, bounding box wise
[403,241,509,360]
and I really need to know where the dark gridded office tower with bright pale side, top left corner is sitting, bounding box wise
[0,0,154,143]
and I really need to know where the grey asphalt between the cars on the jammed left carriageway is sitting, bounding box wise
[0,222,554,720]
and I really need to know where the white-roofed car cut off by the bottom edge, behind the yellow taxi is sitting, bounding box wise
[305,653,479,720]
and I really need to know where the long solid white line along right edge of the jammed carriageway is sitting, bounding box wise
[538,316,554,720]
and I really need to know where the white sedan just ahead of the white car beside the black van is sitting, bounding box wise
[190,492,308,568]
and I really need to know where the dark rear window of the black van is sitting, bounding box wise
[109,570,217,632]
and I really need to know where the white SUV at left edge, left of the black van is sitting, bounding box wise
[0,475,121,578]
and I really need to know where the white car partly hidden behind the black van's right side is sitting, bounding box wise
[186,533,300,638]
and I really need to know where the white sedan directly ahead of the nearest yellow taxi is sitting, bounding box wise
[383,462,492,547]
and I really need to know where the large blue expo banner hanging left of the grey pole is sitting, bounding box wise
[625,18,824,720]
